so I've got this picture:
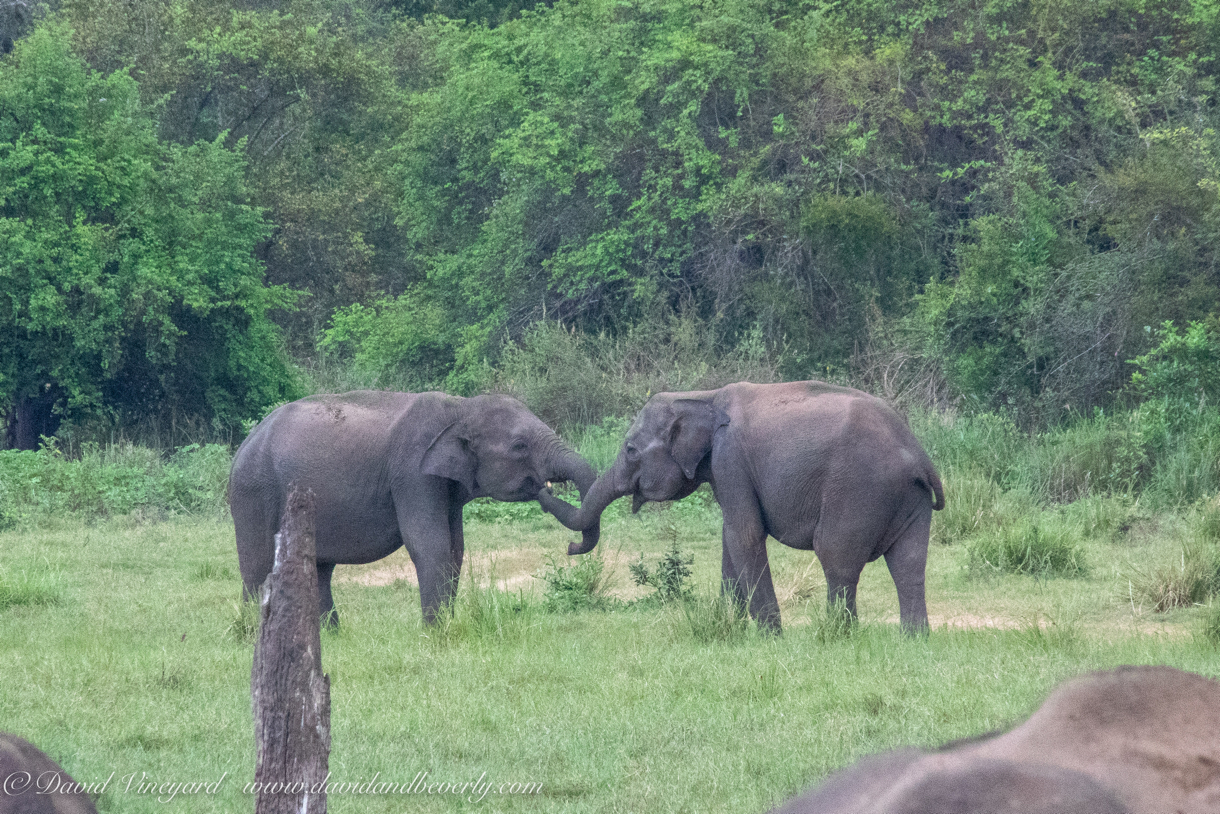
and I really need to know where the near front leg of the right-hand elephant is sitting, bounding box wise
[717,495,781,633]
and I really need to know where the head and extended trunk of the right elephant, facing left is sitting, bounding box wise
[538,393,728,554]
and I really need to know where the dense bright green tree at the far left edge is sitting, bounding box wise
[0,24,295,432]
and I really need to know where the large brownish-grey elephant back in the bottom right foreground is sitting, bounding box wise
[773,666,1220,814]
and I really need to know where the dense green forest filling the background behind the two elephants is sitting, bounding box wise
[0,0,1220,447]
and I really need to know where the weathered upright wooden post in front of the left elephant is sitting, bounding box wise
[250,486,331,814]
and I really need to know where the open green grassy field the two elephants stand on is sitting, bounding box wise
[0,483,1220,813]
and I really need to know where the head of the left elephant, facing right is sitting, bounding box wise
[423,395,599,549]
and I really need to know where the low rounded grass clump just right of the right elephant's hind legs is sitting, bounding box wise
[967,520,1087,576]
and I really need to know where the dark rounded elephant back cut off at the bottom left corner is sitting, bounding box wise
[0,732,98,814]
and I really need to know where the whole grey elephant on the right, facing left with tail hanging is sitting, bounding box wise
[539,382,944,632]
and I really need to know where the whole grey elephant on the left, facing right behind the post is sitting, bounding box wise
[229,391,598,624]
